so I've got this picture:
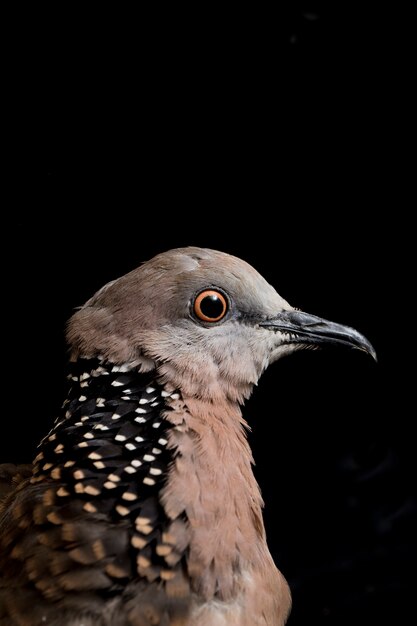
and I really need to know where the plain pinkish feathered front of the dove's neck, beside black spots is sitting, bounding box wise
[162,382,269,600]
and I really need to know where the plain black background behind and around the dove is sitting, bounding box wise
[1,2,417,626]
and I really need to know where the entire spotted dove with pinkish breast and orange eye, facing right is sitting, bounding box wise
[0,245,376,626]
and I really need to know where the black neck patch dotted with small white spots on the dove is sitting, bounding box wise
[32,359,172,520]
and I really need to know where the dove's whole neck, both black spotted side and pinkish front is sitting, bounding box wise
[31,359,266,599]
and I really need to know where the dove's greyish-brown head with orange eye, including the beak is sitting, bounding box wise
[67,247,376,403]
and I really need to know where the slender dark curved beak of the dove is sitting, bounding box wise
[260,311,377,361]
